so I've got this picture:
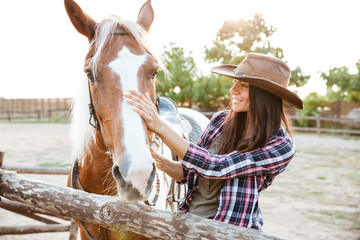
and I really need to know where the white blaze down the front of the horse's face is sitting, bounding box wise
[109,46,154,200]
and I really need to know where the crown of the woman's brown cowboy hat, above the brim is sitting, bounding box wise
[235,53,291,87]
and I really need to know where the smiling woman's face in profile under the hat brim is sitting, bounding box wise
[230,79,249,112]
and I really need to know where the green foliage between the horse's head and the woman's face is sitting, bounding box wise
[156,43,232,108]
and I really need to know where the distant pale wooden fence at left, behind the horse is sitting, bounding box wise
[0,98,72,122]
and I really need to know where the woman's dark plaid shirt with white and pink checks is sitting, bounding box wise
[179,111,295,230]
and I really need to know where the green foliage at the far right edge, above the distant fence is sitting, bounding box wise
[321,60,360,102]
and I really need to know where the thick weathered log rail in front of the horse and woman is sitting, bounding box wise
[0,152,279,240]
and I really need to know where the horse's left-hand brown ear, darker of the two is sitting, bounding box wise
[64,0,96,41]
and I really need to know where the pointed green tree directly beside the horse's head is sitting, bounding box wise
[156,43,197,107]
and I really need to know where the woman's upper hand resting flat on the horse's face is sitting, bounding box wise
[124,90,162,133]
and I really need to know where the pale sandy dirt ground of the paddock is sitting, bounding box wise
[0,123,360,240]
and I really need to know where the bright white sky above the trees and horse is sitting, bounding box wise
[0,0,360,98]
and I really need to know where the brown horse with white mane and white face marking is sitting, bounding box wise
[64,0,206,240]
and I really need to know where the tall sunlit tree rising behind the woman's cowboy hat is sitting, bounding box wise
[205,14,310,87]
